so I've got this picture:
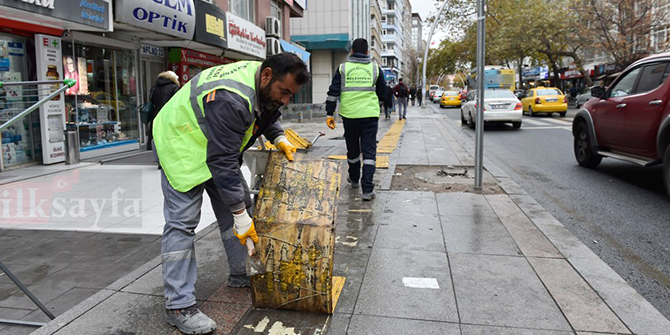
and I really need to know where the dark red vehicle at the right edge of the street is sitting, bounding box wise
[572,53,670,196]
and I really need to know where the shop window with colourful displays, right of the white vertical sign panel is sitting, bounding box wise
[63,42,139,151]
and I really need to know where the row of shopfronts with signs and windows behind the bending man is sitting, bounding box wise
[0,0,307,170]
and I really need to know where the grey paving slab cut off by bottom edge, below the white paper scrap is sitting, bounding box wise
[347,315,461,335]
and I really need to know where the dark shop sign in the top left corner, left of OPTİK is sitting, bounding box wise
[0,0,112,30]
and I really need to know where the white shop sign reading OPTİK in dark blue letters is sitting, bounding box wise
[114,0,196,40]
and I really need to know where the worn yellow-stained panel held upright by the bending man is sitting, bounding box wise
[252,152,342,313]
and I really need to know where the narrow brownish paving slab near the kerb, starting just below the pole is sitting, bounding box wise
[486,195,563,258]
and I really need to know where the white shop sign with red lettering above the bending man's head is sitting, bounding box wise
[226,12,265,59]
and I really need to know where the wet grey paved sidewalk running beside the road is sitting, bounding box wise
[5,107,670,335]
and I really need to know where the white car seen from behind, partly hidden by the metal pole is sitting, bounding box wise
[461,88,523,129]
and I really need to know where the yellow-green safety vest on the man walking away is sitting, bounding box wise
[340,60,380,119]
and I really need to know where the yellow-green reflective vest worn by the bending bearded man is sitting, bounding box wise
[153,62,261,192]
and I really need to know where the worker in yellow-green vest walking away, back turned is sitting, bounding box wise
[326,38,386,201]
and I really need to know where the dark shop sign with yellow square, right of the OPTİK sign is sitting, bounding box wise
[193,1,228,49]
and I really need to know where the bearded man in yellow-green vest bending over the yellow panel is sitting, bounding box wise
[153,53,309,334]
